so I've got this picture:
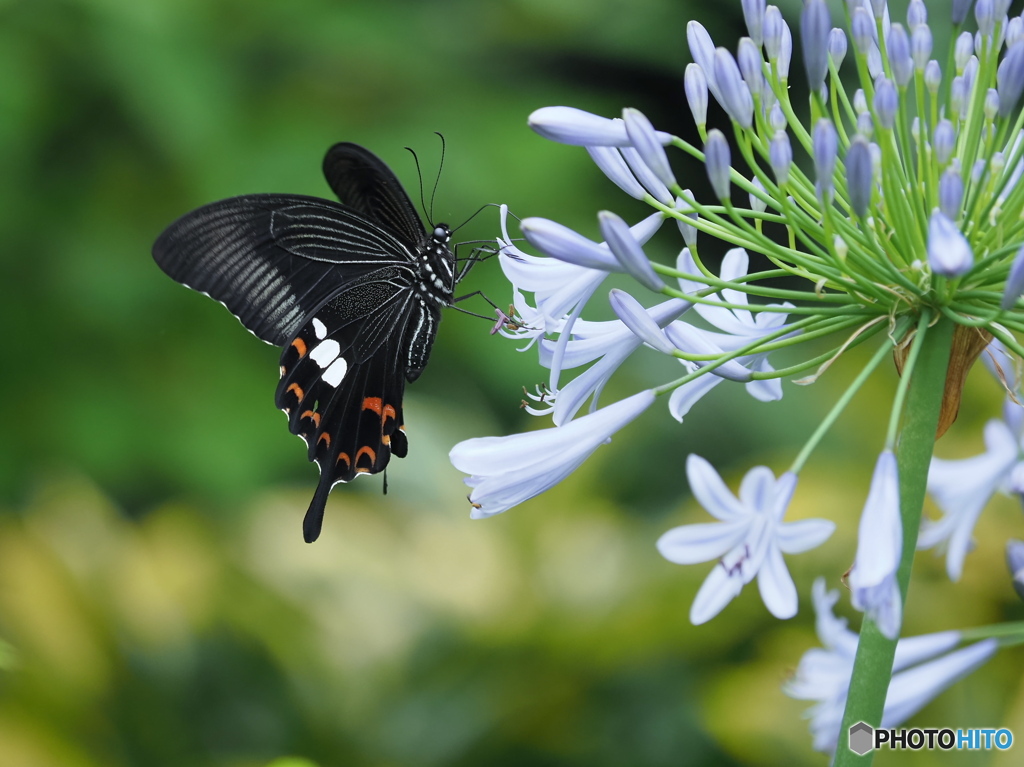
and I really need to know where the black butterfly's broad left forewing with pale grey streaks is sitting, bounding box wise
[153,195,414,346]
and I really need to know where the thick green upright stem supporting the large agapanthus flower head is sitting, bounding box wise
[835,317,954,767]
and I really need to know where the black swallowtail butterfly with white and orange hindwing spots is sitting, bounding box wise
[153,143,464,543]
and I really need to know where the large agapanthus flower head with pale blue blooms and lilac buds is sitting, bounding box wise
[452,0,1024,742]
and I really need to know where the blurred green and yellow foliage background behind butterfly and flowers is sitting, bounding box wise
[0,0,1024,767]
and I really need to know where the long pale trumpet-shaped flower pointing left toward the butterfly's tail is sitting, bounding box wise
[449,389,654,519]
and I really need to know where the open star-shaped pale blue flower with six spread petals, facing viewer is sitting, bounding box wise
[657,455,836,625]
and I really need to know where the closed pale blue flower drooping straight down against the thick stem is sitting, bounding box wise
[849,450,903,639]
